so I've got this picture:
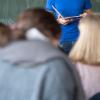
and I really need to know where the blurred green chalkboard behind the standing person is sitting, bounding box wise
[0,0,100,24]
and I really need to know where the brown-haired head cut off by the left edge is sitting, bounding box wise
[0,23,12,47]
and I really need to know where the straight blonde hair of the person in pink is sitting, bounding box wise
[69,14,100,65]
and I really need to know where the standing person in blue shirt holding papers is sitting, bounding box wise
[46,0,92,54]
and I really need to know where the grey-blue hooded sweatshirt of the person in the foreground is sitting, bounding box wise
[0,39,86,100]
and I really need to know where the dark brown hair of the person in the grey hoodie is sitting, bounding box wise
[17,8,61,38]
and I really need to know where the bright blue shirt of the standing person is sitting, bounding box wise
[46,0,91,43]
